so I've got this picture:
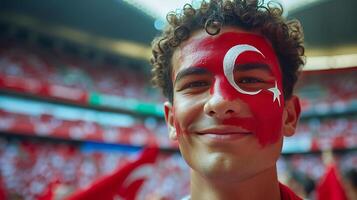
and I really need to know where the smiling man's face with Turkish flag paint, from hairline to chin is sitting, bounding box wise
[165,28,298,179]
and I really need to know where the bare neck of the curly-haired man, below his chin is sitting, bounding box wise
[191,166,280,200]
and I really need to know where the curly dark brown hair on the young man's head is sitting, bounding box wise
[151,0,305,102]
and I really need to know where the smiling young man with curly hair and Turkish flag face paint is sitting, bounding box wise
[152,0,304,200]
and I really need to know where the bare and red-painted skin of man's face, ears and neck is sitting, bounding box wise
[165,27,300,200]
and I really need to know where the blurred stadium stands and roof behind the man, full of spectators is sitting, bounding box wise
[0,0,357,199]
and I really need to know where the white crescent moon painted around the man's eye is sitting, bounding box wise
[223,44,265,95]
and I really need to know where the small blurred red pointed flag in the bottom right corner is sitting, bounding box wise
[316,164,347,200]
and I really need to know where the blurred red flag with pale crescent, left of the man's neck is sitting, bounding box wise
[68,147,159,200]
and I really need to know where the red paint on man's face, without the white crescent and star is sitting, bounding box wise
[177,32,284,146]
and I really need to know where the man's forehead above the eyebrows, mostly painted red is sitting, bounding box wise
[172,27,280,76]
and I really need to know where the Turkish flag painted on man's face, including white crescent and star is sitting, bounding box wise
[173,32,284,146]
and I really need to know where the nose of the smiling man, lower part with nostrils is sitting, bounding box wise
[203,86,241,119]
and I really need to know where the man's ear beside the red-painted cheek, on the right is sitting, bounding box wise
[283,95,301,137]
